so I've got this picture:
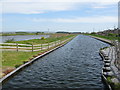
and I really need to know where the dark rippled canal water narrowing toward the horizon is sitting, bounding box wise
[3,35,109,90]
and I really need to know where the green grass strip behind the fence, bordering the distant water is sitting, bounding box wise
[7,35,74,45]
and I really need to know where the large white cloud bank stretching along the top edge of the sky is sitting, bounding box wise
[1,0,119,14]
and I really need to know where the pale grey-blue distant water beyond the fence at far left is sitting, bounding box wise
[0,35,49,43]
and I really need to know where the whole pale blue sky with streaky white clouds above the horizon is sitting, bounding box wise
[0,0,119,32]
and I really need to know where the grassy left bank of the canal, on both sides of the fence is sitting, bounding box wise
[2,35,75,75]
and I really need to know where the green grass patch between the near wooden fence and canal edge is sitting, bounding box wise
[2,51,45,67]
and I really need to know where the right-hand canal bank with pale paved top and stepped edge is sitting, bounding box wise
[92,36,120,90]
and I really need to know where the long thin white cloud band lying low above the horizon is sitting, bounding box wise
[32,16,118,23]
